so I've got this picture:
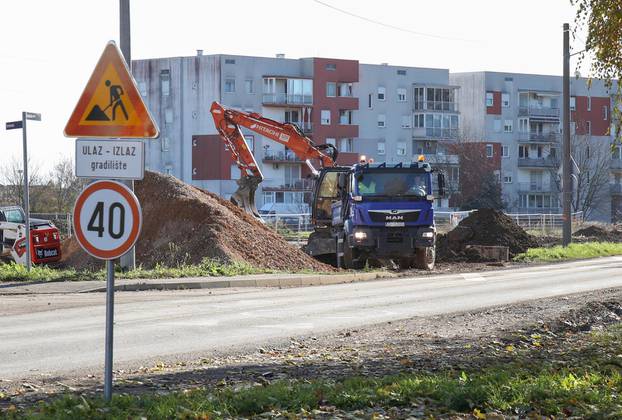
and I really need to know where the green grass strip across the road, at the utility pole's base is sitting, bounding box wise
[514,242,622,262]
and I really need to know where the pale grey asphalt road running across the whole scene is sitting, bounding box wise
[0,257,622,379]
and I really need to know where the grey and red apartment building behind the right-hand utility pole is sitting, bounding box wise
[449,72,622,221]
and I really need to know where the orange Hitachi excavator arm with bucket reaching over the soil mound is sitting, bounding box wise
[210,102,337,217]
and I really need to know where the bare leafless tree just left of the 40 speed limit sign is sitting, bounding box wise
[48,158,85,213]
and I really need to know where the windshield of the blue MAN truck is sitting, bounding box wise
[356,171,429,197]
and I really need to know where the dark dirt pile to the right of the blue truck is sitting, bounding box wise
[436,209,540,262]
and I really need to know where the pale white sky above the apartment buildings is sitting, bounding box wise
[0,0,587,172]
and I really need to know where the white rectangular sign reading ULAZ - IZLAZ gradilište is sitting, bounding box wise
[76,139,145,180]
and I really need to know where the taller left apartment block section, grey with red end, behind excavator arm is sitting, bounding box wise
[132,51,359,212]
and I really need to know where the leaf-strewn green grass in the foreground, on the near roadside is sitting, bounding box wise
[4,327,622,419]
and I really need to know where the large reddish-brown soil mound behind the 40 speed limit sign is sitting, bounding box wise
[63,172,332,271]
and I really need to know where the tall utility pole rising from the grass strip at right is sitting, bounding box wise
[562,23,572,246]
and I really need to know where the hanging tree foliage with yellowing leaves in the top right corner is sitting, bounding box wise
[570,0,622,142]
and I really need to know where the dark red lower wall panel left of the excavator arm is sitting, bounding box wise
[192,134,234,181]
